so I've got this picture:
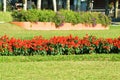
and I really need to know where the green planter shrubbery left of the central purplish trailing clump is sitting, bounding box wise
[12,9,55,22]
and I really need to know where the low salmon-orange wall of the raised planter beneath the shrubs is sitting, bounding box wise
[11,22,109,30]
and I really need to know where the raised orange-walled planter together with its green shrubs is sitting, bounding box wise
[12,10,111,30]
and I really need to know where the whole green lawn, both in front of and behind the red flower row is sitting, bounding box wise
[0,23,120,80]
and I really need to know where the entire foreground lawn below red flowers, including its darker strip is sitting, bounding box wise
[0,54,120,80]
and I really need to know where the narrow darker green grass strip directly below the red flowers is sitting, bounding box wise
[0,54,120,62]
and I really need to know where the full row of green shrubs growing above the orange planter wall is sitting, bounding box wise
[12,9,111,26]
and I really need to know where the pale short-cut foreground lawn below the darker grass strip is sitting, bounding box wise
[0,61,120,80]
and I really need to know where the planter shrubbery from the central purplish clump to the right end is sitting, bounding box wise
[54,10,111,26]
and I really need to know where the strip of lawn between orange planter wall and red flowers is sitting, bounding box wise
[0,23,120,39]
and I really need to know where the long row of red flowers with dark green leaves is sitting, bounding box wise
[0,35,120,56]
